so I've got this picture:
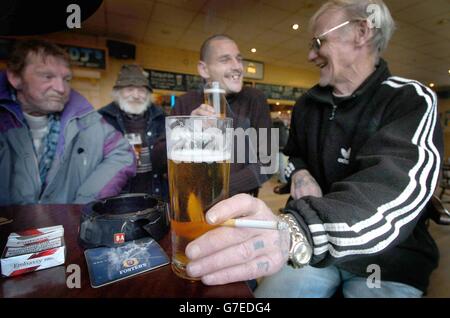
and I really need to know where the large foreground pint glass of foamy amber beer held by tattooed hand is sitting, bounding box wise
[166,116,233,280]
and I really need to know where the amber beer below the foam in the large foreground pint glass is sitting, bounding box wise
[169,153,230,279]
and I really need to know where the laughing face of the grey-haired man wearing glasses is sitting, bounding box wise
[308,10,355,93]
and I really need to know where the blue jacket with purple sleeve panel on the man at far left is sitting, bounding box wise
[0,72,136,205]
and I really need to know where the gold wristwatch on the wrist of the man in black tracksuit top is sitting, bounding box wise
[279,213,312,268]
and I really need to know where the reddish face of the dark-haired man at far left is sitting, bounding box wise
[8,53,72,116]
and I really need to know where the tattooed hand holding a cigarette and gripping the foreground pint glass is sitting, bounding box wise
[186,194,290,285]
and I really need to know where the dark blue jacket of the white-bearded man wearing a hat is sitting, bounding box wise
[99,102,169,200]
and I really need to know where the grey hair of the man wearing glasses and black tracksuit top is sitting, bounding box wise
[309,0,395,55]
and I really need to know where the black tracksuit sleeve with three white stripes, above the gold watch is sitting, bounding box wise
[287,82,443,266]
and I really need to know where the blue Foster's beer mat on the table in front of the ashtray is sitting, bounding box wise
[84,237,170,288]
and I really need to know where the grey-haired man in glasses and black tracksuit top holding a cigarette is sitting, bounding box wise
[181,0,443,297]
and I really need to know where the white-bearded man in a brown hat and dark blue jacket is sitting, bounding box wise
[99,64,168,199]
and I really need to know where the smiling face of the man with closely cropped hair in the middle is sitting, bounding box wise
[198,39,244,94]
